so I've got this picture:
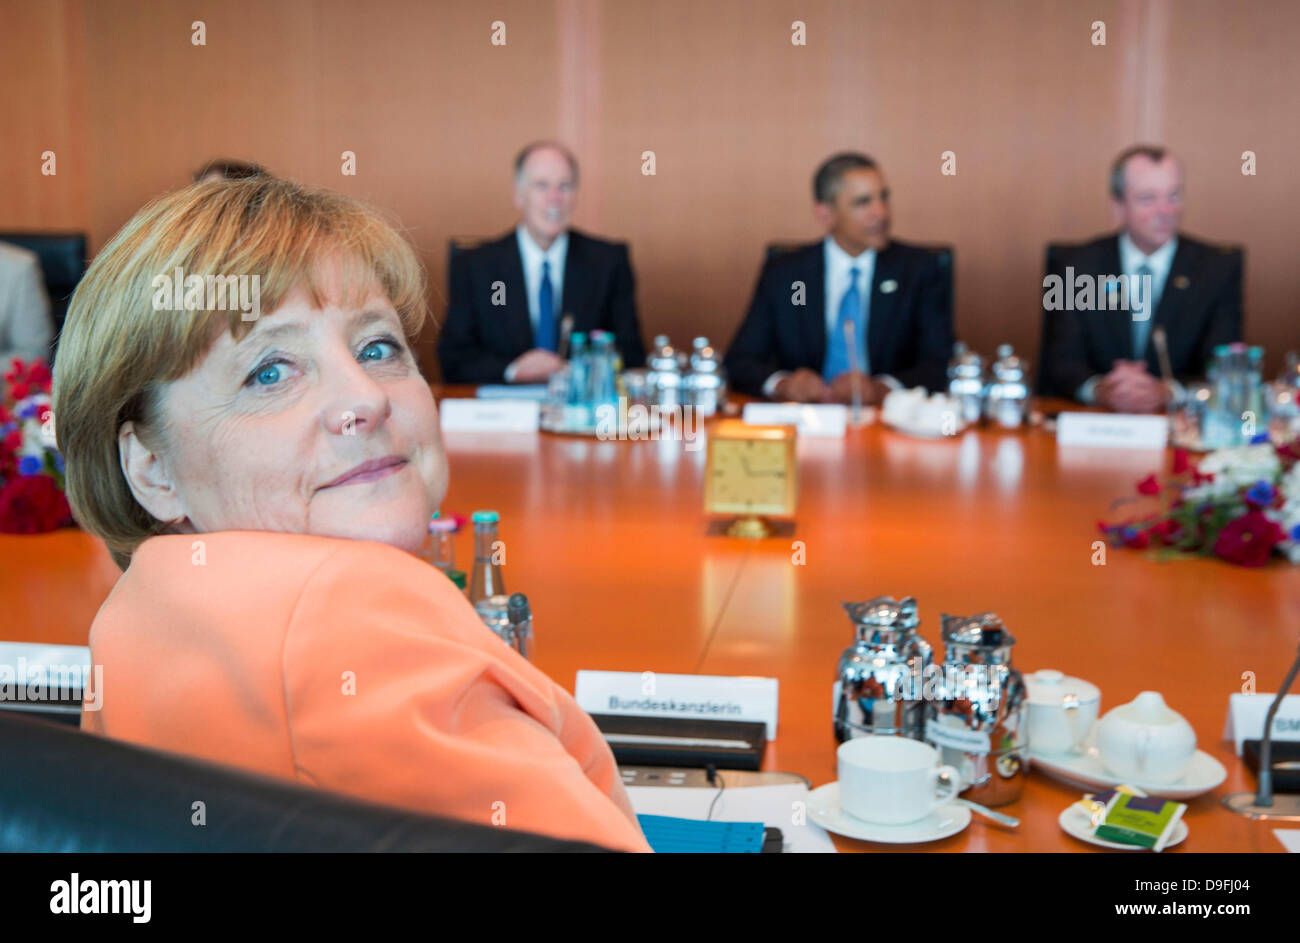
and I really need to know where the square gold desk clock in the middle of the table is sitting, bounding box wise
[705,419,796,540]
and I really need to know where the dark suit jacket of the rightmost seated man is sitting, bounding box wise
[1041,233,1243,399]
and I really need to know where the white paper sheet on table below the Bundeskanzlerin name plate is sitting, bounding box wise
[628,783,835,855]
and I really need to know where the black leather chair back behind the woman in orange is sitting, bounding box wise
[0,711,608,853]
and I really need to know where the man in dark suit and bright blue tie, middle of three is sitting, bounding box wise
[727,153,953,403]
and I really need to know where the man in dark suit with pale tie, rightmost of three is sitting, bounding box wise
[1043,144,1242,412]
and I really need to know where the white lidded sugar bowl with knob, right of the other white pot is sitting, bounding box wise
[1097,691,1196,786]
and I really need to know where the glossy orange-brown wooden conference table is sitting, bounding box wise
[0,388,1300,852]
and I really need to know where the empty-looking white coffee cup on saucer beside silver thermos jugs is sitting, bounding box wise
[836,735,959,825]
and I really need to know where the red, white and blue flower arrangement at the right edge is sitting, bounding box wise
[1097,434,1300,567]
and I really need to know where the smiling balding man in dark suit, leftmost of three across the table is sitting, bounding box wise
[438,142,645,384]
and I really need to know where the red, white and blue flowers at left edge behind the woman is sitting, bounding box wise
[0,358,72,533]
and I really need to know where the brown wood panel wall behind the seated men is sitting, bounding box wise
[0,0,1300,373]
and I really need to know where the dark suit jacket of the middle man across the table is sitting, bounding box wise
[725,241,953,395]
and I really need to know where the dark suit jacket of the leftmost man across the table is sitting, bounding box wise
[438,229,645,384]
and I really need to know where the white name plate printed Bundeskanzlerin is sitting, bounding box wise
[573,671,777,740]
